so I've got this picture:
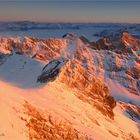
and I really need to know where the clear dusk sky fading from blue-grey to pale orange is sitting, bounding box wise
[0,0,140,23]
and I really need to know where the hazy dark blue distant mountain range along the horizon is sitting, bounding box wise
[0,21,140,31]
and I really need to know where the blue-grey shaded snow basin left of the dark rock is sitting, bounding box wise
[0,53,44,88]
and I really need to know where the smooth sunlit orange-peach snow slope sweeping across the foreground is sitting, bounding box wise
[0,77,139,140]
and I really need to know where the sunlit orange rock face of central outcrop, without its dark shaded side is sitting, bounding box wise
[59,61,116,118]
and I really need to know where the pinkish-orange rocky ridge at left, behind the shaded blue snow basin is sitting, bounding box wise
[0,37,68,62]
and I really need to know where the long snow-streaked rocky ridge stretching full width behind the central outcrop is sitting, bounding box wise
[0,32,140,95]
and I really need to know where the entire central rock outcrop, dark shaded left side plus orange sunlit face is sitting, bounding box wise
[37,55,116,119]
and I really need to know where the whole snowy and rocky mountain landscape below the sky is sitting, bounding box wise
[0,22,140,140]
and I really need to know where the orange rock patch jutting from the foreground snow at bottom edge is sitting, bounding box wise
[22,102,88,140]
